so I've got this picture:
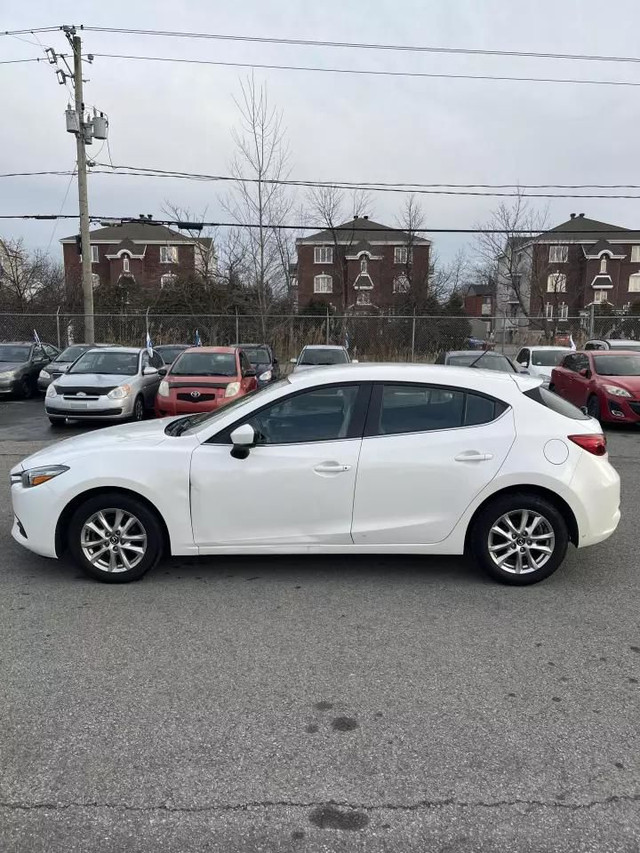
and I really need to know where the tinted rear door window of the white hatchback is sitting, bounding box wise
[367,385,507,435]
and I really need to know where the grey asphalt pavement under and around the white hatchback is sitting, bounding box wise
[0,400,640,853]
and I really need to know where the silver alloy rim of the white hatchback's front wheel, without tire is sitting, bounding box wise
[80,507,147,572]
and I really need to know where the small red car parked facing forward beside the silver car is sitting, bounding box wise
[155,347,258,418]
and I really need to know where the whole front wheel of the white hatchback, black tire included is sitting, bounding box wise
[68,492,164,583]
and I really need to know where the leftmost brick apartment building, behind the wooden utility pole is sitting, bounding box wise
[60,217,213,298]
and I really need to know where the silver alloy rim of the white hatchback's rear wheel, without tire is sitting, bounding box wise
[487,509,556,575]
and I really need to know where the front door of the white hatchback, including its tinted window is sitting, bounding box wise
[191,384,370,553]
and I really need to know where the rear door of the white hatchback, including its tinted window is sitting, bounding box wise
[352,382,515,545]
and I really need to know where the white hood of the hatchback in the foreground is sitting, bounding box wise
[13,418,180,471]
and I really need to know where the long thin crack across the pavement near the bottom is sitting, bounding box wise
[0,794,640,814]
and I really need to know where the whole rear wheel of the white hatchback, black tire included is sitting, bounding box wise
[468,492,569,586]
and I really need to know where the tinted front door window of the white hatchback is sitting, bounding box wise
[246,385,358,444]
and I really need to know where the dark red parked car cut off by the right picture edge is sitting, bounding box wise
[549,350,640,424]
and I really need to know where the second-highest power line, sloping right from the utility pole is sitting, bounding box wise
[93,53,640,87]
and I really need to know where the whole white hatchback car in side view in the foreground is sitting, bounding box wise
[11,364,620,584]
